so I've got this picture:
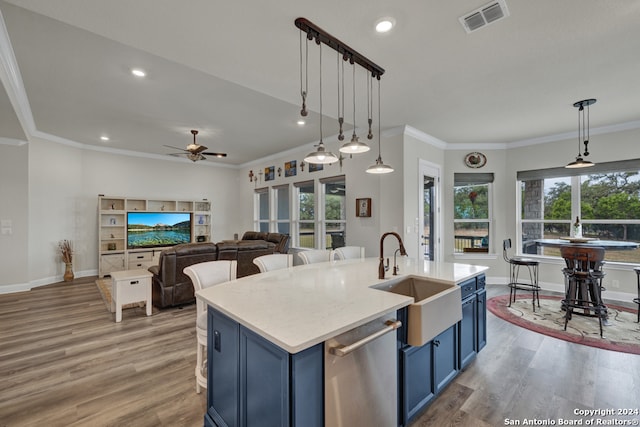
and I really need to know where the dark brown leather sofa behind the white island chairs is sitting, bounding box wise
[149,232,289,308]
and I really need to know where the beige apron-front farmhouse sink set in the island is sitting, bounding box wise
[373,276,462,346]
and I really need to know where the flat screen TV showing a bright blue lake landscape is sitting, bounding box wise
[127,212,192,249]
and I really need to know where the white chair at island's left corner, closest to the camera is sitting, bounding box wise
[183,260,238,393]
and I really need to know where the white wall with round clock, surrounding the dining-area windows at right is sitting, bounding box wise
[443,125,640,301]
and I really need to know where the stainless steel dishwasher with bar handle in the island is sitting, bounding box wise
[324,312,402,427]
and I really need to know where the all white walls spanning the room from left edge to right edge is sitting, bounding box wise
[5,124,640,299]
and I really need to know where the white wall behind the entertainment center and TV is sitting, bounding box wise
[0,139,240,292]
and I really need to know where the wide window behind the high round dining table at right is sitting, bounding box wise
[518,159,640,263]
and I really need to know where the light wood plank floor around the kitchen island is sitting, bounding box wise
[0,278,640,427]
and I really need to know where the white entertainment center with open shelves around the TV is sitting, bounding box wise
[98,195,211,278]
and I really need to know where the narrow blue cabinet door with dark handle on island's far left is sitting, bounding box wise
[207,308,240,426]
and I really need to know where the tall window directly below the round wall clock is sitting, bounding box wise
[453,173,493,253]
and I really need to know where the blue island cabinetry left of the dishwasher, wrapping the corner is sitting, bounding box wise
[205,307,324,427]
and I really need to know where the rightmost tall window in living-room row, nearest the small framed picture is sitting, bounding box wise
[320,175,347,249]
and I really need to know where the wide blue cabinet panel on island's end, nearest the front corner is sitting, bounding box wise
[241,326,289,426]
